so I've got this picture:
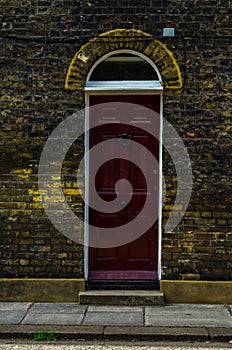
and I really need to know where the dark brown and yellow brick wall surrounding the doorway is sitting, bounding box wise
[0,0,232,280]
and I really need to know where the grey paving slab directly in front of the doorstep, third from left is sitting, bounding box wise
[83,312,143,326]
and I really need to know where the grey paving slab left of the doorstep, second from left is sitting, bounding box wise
[22,313,84,325]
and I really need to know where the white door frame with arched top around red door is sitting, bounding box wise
[84,50,163,281]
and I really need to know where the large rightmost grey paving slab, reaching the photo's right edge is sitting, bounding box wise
[145,304,232,327]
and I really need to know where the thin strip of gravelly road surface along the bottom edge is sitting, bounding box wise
[0,341,232,350]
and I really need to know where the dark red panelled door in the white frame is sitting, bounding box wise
[89,95,160,280]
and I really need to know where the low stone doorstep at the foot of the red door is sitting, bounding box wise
[79,290,164,306]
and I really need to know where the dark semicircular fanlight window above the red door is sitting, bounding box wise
[89,54,159,81]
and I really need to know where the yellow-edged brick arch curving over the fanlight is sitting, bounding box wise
[65,29,182,91]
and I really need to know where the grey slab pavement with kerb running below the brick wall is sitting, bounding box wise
[0,302,232,343]
